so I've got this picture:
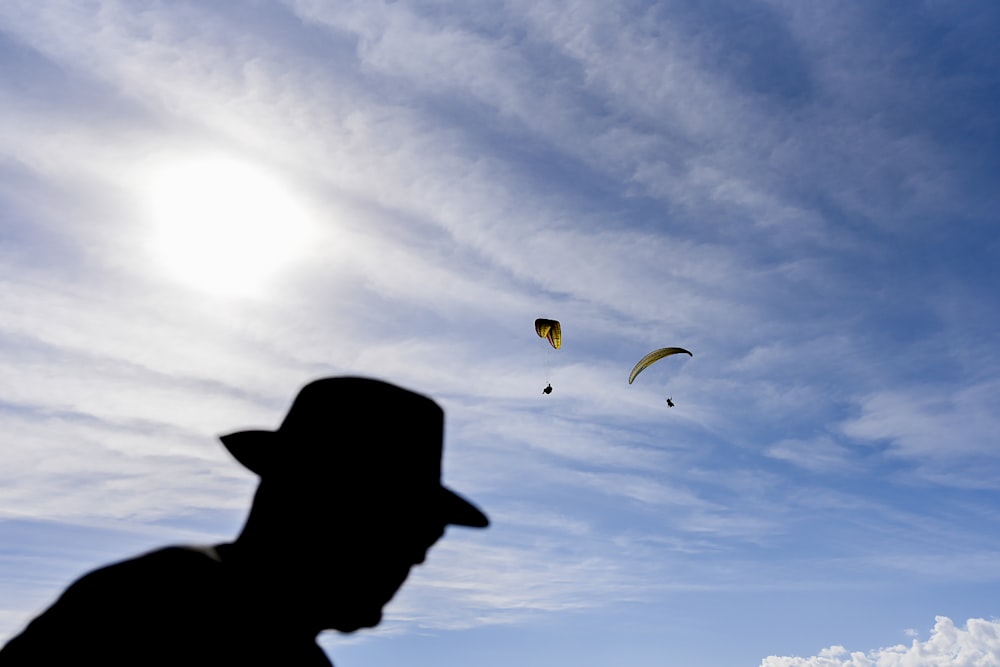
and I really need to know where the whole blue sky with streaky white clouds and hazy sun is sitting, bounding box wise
[0,0,1000,667]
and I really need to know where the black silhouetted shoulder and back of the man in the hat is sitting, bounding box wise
[0,547,330,667]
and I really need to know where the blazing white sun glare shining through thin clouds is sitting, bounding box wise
[148,157,309,296]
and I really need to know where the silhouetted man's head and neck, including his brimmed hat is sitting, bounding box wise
[220,377,489,632]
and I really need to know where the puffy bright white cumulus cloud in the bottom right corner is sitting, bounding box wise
[760,616,1000,667]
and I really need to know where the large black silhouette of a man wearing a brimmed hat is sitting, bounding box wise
[0,377,489,667]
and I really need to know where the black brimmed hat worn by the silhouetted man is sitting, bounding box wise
[219,377,489,528]
